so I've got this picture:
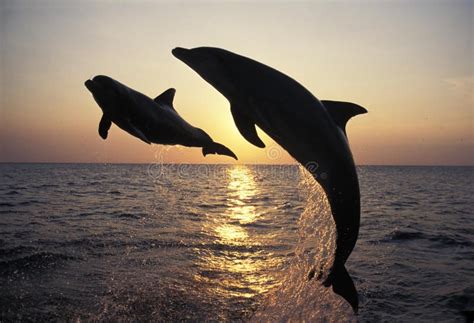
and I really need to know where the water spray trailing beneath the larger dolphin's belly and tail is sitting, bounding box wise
[251,167,356,322]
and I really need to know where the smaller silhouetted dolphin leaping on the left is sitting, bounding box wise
[84,75,237,159]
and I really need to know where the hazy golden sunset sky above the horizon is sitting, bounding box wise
[0,0,474,165]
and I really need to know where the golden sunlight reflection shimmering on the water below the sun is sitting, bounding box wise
[198,165,277,298]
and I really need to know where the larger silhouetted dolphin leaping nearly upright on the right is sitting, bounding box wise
[172,47,367,312]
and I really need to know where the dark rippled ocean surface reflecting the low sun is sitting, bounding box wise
[0,164,474,322]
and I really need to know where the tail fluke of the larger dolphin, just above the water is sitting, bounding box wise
[324,265,359,313]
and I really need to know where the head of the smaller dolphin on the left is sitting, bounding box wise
[84,75,124,113]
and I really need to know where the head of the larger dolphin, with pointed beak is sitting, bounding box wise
[171,47,235,95]
